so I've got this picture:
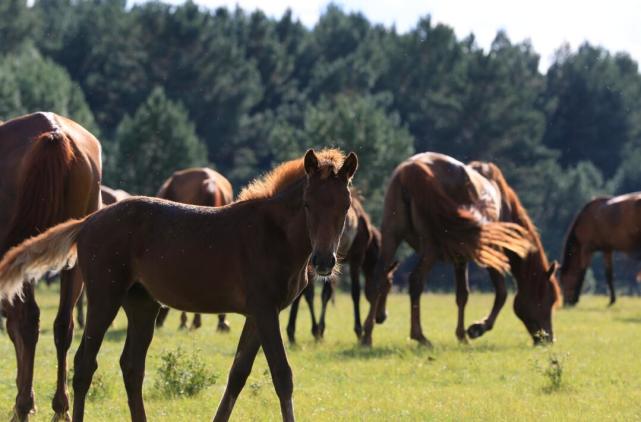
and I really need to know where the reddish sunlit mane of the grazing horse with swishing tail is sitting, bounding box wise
[468,161,562,304]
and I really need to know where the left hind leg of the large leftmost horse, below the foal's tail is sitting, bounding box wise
[2,283,40,421]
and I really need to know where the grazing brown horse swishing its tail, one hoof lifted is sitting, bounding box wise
[363,153,560,345]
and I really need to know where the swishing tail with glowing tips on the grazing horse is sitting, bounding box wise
[400,161,533,273]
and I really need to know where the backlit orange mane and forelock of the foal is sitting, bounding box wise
[238,148,345,201]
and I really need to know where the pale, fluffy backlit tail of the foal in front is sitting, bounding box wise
[0,217,86,302]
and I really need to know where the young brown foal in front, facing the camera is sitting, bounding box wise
[0,150,358,422]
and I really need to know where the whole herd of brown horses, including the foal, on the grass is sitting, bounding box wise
[0,113,641,421]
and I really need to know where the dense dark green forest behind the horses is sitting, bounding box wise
[0,0,641,294]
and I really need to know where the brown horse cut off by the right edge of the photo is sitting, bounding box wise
[561,192,641,305]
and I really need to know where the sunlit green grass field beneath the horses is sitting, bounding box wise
[0,287,641,421]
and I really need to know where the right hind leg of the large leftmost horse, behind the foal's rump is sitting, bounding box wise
[51,267,83,421]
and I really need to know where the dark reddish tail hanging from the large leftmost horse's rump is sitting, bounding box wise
[0,130,75,252]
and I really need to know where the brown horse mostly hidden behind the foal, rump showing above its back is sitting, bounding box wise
[156,167,234,332]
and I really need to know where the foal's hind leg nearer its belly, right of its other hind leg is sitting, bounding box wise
[120,285,160,421]
